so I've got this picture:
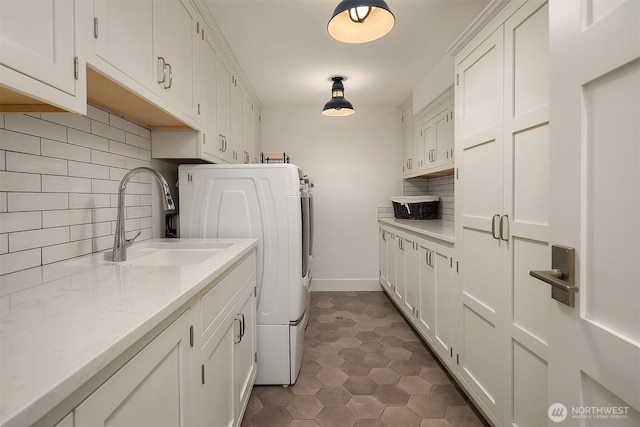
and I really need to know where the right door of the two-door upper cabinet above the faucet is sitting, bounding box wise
[153,0,199,118]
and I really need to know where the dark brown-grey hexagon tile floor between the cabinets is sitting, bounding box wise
[242,292,488,427]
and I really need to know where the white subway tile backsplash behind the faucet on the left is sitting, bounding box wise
[0,106,152,275]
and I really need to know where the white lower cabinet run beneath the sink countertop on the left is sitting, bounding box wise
[65,252,257,427]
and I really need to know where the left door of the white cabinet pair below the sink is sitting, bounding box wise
[198,315,238,427]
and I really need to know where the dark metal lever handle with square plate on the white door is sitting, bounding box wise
[529,245,578,307]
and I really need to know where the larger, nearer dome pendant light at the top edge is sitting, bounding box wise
[327,0,396,43]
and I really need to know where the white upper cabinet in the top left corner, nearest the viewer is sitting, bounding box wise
[0,0,86,113]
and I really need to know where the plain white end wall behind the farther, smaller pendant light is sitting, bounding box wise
[262,106,402,290]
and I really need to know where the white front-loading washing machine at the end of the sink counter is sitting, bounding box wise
[178,164,313,385]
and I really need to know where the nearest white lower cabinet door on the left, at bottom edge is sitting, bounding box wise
[75,311,193,426]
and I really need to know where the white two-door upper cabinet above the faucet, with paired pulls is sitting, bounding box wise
[90,0,199,127]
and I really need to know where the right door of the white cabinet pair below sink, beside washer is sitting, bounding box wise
[234,281,257,421]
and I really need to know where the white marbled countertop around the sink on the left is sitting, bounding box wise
[0,239,257,427]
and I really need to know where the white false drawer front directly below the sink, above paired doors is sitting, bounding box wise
[200,252,256,336]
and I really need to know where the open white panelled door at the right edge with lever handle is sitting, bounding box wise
[540,0,640,427]
